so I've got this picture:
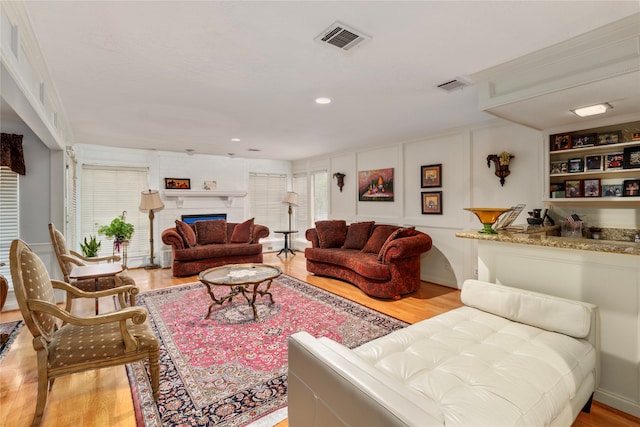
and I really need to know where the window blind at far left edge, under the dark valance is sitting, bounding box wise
[0,166,20,289]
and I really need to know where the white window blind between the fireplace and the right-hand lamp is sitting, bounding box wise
[249,173,289,233]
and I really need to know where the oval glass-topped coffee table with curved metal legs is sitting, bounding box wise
[198,264,282,321]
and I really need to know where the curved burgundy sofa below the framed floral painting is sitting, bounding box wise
[304,220,432,299]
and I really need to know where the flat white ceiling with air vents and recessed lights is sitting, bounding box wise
[12,1,640,160]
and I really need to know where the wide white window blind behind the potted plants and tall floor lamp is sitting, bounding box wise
[80,165,149,261]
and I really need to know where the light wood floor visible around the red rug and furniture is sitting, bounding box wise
[0,253,640,427]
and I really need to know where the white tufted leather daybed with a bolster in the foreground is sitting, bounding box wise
[288,280,599,427]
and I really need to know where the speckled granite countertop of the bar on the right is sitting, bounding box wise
[456,230,640,256]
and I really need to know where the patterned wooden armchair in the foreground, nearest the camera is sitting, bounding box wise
[9,240,160,426]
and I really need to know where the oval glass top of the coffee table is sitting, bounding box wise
[198,264,282,286]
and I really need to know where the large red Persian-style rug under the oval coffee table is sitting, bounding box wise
[127,274,407,427]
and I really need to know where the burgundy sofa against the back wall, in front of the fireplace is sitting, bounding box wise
[162,218,269,276]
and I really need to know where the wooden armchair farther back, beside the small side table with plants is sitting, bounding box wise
[49,224,139,311]
